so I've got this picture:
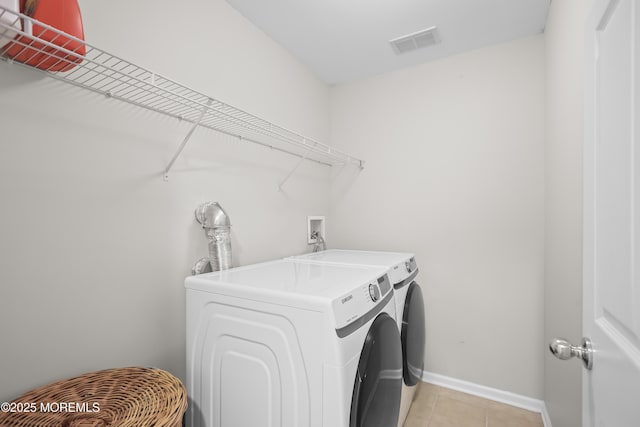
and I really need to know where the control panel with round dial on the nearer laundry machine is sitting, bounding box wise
[333,274,393,330]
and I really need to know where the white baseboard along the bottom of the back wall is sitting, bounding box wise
[422,371,551,427]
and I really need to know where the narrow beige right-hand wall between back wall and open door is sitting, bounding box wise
[544,0,591,427]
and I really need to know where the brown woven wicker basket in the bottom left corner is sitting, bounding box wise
[0,368,187,427]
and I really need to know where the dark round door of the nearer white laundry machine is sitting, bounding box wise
[349,313,402,427]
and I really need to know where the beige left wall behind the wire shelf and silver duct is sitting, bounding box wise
[0,0,330,401]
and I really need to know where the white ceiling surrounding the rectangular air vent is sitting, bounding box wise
[227,0,551,84]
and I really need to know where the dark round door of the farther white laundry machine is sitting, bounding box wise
[401,282,425,386]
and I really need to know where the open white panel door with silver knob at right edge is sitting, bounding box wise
[583,0,640,427]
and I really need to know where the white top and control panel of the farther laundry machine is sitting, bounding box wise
[288,249,418,288]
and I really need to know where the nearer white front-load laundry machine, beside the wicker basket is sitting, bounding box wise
[185,260,402,427]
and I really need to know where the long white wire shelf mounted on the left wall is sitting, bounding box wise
[0,5,364,176]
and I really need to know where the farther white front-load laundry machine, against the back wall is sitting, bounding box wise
[288,249,425,427]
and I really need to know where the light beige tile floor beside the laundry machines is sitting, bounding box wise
[404,383,544,427]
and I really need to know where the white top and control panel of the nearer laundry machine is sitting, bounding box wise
[185,260,393,336]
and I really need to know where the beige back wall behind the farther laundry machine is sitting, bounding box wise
[327,36,544,399]
